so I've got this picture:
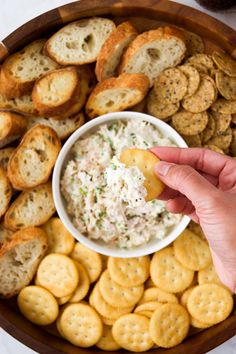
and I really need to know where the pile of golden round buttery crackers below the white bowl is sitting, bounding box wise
[17,217,233,352]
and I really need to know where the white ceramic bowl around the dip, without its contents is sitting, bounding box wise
[53,112,190,258]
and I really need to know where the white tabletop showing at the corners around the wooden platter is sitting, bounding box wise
[0,0,236,354]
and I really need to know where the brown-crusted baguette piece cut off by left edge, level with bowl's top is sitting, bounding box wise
[0,111,26,148]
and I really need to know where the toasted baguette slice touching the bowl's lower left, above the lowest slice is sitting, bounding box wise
[4,182,56,231]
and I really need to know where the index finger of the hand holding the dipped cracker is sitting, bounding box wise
[150,146,236,176]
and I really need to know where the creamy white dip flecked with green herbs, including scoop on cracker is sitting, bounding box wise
[61,120,181,249]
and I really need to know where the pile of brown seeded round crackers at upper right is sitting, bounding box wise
[147,51,236,157]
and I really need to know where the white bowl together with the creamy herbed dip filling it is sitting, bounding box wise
[53,112,190,257]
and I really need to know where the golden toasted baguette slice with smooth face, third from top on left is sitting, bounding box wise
[32,67,80,117]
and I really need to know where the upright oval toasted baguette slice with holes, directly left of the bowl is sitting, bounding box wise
[7,124,61,190]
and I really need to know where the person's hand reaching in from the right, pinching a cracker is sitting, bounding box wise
[151,147,236,292]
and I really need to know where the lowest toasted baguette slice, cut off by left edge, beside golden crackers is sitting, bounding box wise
[0,227,48,298]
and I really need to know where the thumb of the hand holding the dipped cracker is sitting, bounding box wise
[155,161,216,207]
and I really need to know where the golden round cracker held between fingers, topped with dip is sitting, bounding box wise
[120,149,164,202]
